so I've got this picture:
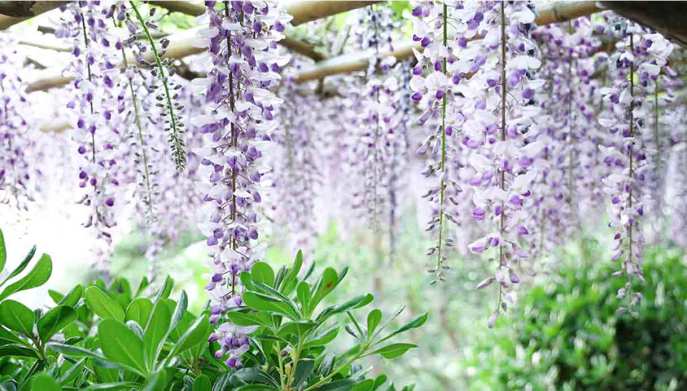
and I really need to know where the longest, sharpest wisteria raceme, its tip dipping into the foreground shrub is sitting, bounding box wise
[195,0,288,367]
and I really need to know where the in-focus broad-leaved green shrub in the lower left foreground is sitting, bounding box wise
[0,231,427,391]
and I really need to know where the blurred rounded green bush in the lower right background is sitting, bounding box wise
[465,243,687,390]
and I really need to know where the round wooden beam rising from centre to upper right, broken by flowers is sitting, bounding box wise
[295,1,601,83]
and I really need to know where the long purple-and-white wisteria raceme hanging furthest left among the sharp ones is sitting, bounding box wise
[57,2,125,274]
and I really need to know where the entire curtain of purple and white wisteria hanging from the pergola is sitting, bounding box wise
[0,0,687,368]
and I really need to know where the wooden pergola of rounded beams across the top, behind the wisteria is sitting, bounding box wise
[0,0,687,92]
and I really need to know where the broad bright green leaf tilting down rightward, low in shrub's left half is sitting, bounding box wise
[98,319,148,376]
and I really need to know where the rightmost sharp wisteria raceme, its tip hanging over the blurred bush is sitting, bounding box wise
[599,19,672,302]
